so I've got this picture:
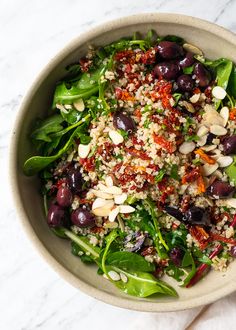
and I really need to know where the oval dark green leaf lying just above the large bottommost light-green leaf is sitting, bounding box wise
[106,251,155,272]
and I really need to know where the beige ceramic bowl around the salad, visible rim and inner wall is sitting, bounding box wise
[10,14,236,312]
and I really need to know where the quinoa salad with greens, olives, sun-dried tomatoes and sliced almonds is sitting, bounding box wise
[24,31,236,298]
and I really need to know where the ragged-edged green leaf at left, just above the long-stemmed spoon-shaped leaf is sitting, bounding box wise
[31,115,64,142]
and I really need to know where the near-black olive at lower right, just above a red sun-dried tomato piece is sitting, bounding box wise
[185,206,210,226]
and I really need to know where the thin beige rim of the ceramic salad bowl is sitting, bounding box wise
[9,13,236,312]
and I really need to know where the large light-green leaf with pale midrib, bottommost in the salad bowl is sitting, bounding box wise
[107,266,178,298]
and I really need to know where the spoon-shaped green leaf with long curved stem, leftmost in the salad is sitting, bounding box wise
[23,115,90,176]
